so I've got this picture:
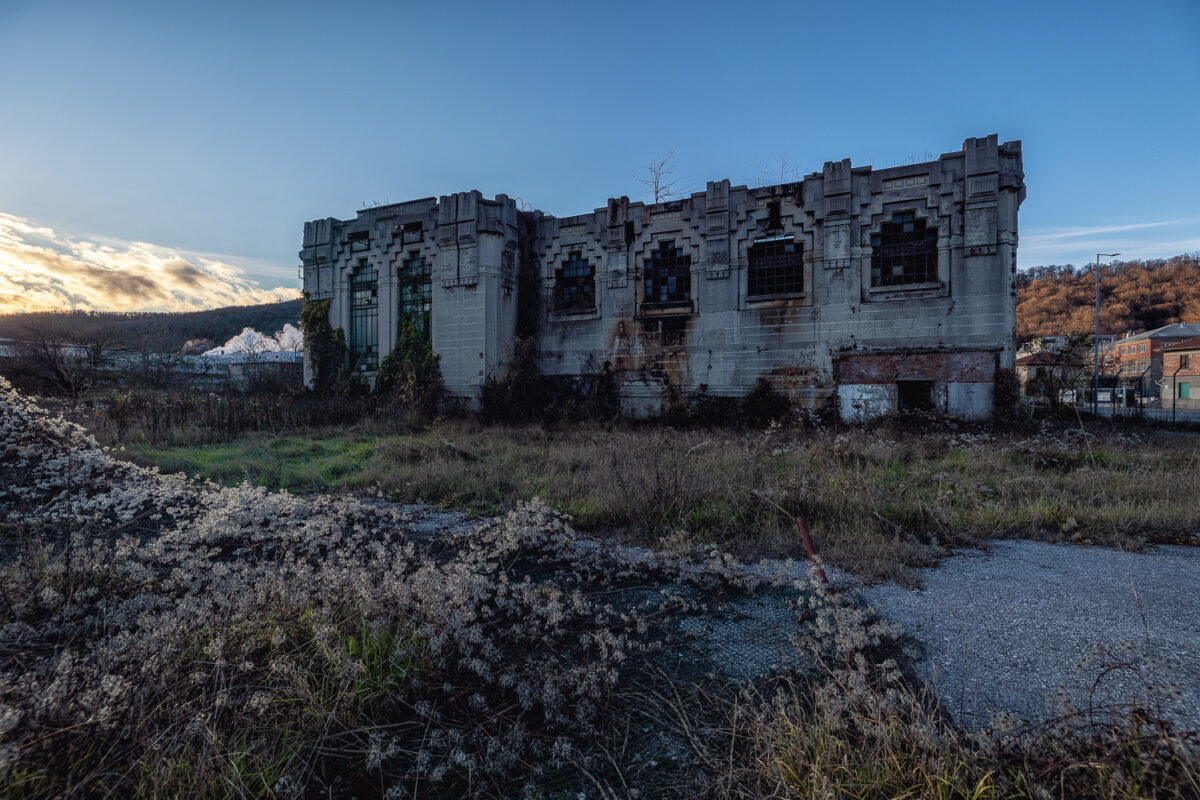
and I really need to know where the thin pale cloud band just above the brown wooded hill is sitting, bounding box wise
[1018,217,1200,267]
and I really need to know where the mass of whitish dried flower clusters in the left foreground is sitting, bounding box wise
[0,379,811,796]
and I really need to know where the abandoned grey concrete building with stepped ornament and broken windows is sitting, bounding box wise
[300,134,1025,420]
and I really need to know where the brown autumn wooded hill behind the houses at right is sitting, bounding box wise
[1016,253,1200,339]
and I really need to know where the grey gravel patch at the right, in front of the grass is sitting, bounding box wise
[863,541,1200,729]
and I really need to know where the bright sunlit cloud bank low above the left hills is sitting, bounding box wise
[0,212,300,312]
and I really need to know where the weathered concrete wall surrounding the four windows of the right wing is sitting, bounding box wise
[539,134,1025,416]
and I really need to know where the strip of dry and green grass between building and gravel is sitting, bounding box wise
[130,422,1200,581]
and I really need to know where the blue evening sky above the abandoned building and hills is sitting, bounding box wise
[0,0,1200,308]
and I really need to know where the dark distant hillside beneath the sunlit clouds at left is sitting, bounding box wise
[0,300,301,353]
